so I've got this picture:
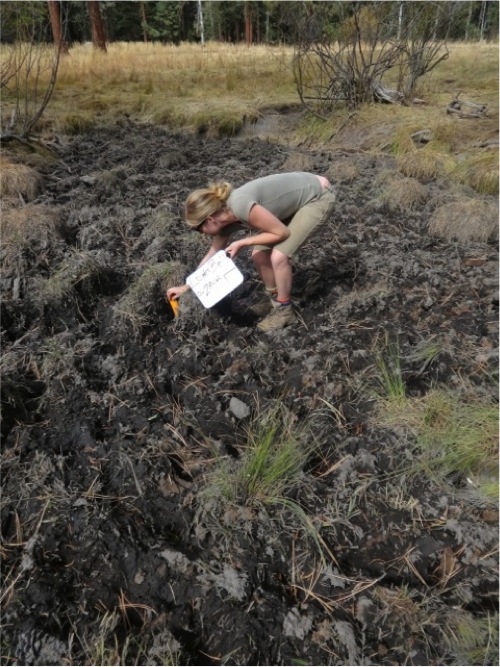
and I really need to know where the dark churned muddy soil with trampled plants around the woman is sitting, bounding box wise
[1,123,498,665]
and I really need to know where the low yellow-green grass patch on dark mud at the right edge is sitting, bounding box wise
[375,336,499,501]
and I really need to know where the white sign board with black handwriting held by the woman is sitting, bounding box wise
[186,250,243,308]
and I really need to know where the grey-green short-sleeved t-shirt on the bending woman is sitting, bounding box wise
[227,171,323,225]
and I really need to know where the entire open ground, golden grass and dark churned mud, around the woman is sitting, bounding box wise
[0,35,498,665]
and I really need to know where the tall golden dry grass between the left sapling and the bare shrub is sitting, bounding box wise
[48,42,297,134]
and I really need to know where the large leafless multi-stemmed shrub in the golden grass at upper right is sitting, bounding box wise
[294,3,448,117]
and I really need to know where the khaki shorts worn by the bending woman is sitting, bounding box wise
[254,185,336,257]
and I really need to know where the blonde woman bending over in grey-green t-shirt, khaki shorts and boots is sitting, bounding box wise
[167,172,335,331]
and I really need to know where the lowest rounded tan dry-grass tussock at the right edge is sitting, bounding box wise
[429,197,498,242]
